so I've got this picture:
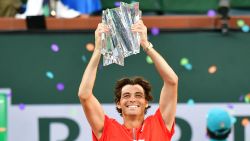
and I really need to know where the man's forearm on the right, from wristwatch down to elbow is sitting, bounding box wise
[142,45,178,84]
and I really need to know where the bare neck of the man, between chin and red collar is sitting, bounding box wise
[123,116,144,129]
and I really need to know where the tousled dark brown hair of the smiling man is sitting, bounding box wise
[114,76,153,115]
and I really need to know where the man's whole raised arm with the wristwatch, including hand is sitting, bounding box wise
[132,21,178,130]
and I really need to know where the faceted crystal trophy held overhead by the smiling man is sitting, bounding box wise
[101,2,141,66]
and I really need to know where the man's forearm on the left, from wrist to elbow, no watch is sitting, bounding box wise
[78,49,101,99]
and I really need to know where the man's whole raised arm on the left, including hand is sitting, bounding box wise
[78,24,108,139]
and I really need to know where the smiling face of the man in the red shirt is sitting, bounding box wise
[117,84,148,116]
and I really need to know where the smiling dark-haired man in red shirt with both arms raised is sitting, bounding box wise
[78,20,178,141]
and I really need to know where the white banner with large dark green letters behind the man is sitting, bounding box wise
[4,104,250,141]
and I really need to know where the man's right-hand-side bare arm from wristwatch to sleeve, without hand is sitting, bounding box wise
[146,41,178,130]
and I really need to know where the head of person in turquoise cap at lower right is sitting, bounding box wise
[207,108,233,141]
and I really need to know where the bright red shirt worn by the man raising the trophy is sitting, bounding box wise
[92,109,174,141]
